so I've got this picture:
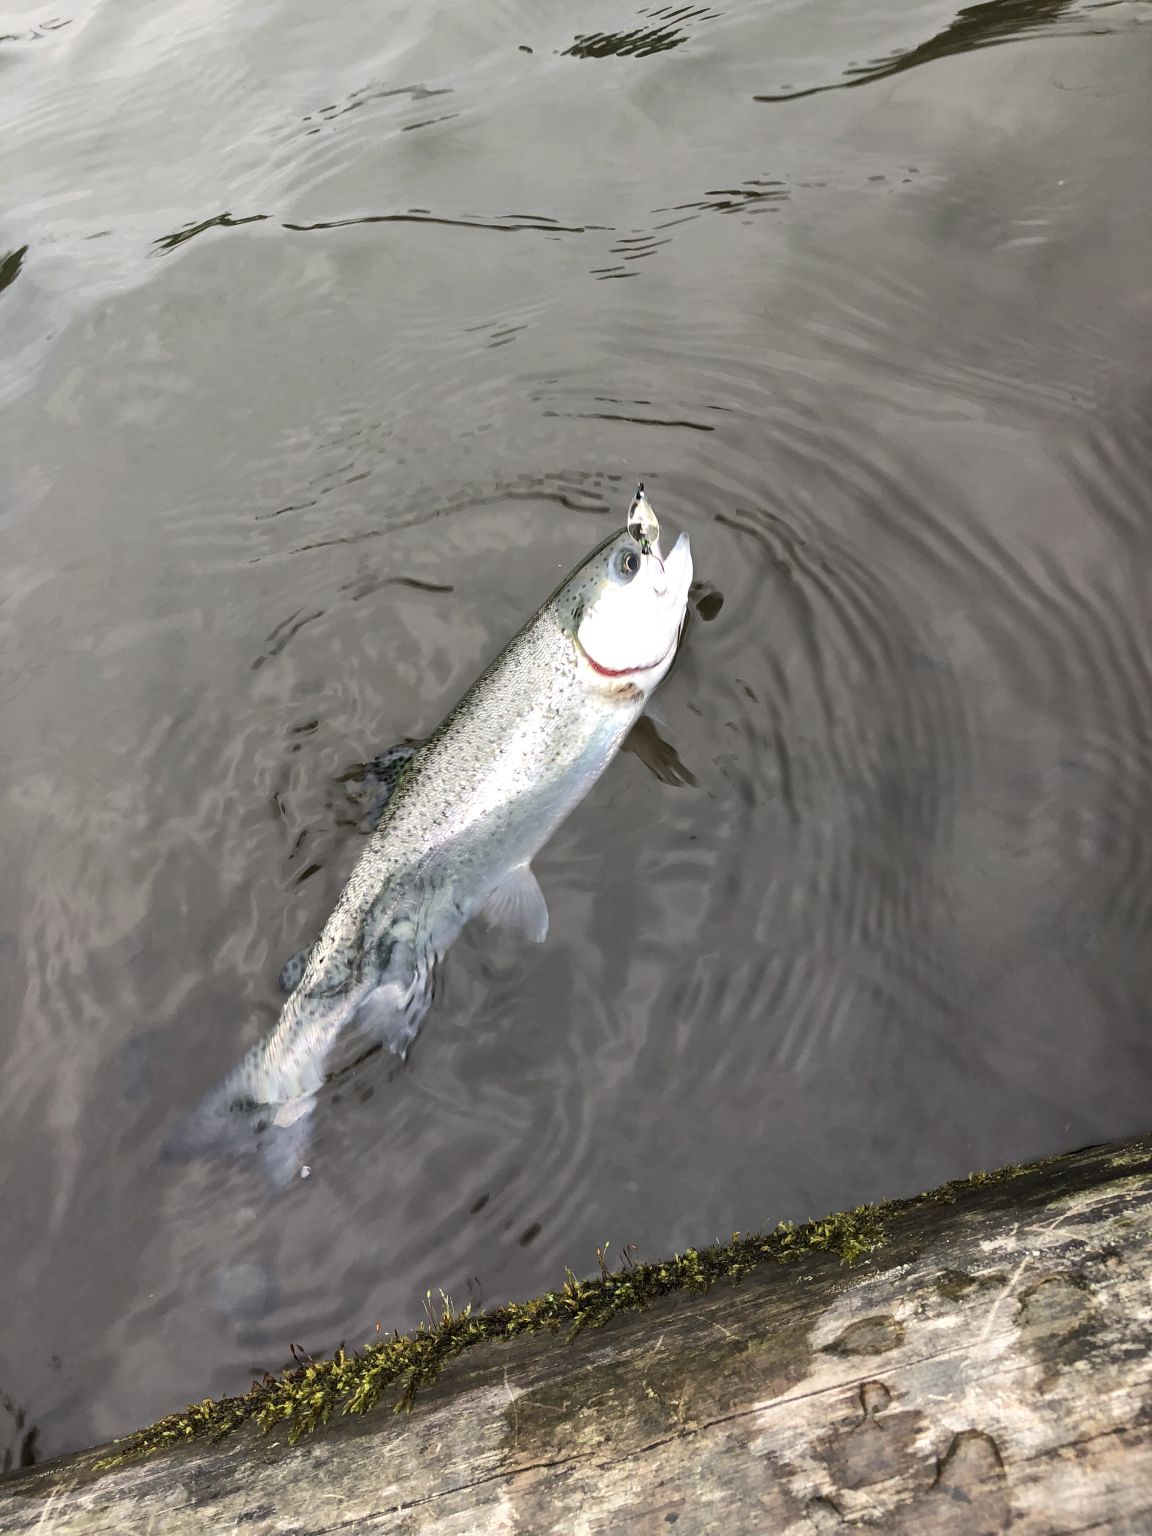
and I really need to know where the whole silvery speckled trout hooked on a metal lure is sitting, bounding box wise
[167,485,693,1183]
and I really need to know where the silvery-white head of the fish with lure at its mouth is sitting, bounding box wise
[561,485,693,699]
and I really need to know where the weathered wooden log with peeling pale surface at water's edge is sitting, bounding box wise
[0,1137,1152,1536]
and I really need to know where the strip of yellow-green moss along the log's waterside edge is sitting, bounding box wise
[94,1164,1041,1471]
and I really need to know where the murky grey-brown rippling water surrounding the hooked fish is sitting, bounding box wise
[0,0,1152,1461]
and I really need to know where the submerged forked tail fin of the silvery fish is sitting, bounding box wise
[160,1063,316,1189]
